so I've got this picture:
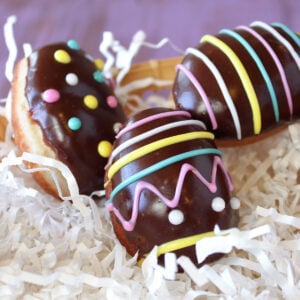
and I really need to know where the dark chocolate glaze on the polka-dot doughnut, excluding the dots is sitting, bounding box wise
[26,43,125,194]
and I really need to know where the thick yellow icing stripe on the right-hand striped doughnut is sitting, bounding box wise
[201,35,261,134]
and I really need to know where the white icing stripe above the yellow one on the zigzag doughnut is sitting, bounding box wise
[107,120,206,165]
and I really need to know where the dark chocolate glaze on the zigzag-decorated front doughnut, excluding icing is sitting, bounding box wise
[106,108,238,264]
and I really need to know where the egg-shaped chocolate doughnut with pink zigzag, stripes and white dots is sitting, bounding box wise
[105,107,240,265]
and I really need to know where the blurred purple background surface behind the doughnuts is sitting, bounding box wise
[0,0,300,97]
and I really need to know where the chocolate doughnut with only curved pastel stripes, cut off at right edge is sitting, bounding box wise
[173,21,300,140]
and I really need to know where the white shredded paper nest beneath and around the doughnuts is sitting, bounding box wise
[0,18,300,300]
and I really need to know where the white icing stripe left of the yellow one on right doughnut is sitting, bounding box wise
[186,48,242,140]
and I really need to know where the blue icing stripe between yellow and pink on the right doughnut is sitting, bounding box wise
[220,29,279,122]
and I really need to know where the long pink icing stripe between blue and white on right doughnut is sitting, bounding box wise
[237,26,293,116]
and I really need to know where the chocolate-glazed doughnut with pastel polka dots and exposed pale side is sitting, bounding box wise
[12,40,126,196]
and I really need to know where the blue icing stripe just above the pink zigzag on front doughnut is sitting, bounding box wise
[105,148,222,204]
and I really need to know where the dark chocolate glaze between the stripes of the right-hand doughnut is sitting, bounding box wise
[173,22,300,139]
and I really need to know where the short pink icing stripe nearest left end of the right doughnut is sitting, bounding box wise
[176,65,218,129]
